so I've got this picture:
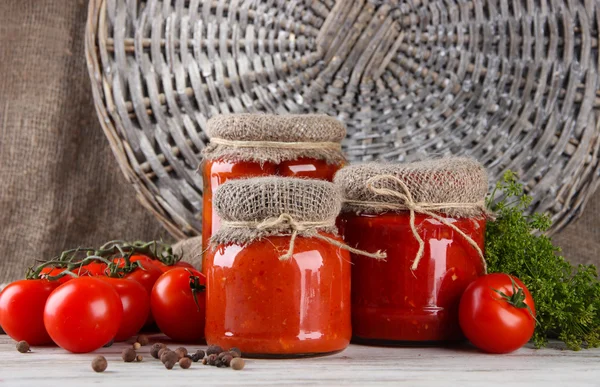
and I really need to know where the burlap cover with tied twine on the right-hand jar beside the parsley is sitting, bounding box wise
[334,157,488,269]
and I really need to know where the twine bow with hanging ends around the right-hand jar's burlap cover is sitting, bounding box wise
[345,175,487,273]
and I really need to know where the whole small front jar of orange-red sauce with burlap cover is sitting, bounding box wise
[205,177,351,358]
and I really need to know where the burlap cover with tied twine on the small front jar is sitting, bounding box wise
[211,177,385,260]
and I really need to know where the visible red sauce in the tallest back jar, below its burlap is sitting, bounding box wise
[202,158,343,271]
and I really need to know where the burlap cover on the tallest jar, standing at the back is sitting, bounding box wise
[203,114,346,163]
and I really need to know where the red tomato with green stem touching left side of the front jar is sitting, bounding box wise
[150,267,206,341]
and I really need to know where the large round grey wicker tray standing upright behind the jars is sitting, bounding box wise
[86,0,600,238]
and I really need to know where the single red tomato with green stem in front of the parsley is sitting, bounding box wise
[459,273,536,353]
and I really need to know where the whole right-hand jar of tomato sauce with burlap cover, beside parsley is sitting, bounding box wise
[335,158,488,345]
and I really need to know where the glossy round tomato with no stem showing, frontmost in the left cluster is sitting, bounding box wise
[44,277,123,353]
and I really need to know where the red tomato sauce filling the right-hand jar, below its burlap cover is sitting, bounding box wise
[338,213,485,345]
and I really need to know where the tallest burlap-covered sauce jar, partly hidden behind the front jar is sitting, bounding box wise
[201,114,346,262]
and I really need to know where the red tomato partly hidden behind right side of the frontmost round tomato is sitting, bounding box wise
[97,276,150,341]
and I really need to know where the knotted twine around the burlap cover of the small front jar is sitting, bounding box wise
[221,213,387,261]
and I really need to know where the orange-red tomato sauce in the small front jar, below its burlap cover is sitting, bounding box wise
[205,234,351,357]
